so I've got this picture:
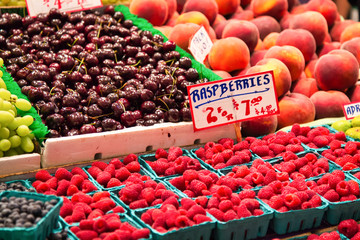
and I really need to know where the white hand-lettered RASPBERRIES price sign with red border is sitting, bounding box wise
[187,71,280,131]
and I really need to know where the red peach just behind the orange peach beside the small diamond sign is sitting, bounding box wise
[222,20,259,52]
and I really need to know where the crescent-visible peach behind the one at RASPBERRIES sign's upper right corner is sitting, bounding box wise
[264,46,305,81]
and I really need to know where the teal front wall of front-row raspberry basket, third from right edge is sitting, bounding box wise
[214,202,274,240]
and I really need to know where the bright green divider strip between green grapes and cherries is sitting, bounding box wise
[0,66,49,144]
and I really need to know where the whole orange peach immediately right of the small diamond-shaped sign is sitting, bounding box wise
[208,37,250,72]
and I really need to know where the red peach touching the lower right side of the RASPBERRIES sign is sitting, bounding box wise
[278,93,315,129]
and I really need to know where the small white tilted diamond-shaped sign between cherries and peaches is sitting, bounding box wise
[189,27,213,63]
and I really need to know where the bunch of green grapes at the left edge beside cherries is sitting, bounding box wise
[0,58,35,157]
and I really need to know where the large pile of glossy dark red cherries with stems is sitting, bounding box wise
[0,7,202,137]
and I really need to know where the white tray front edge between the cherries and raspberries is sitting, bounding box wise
[41,122,236,168]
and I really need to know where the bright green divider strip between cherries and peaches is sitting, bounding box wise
[115,5,222,81]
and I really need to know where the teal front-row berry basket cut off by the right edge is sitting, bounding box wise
[309,172,360,225]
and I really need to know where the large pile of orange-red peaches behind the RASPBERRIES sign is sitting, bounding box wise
[130,0,360,136]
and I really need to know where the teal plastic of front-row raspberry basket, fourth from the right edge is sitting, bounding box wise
[132,202,216,240]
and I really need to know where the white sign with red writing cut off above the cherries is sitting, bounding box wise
[26,0,102,17]
